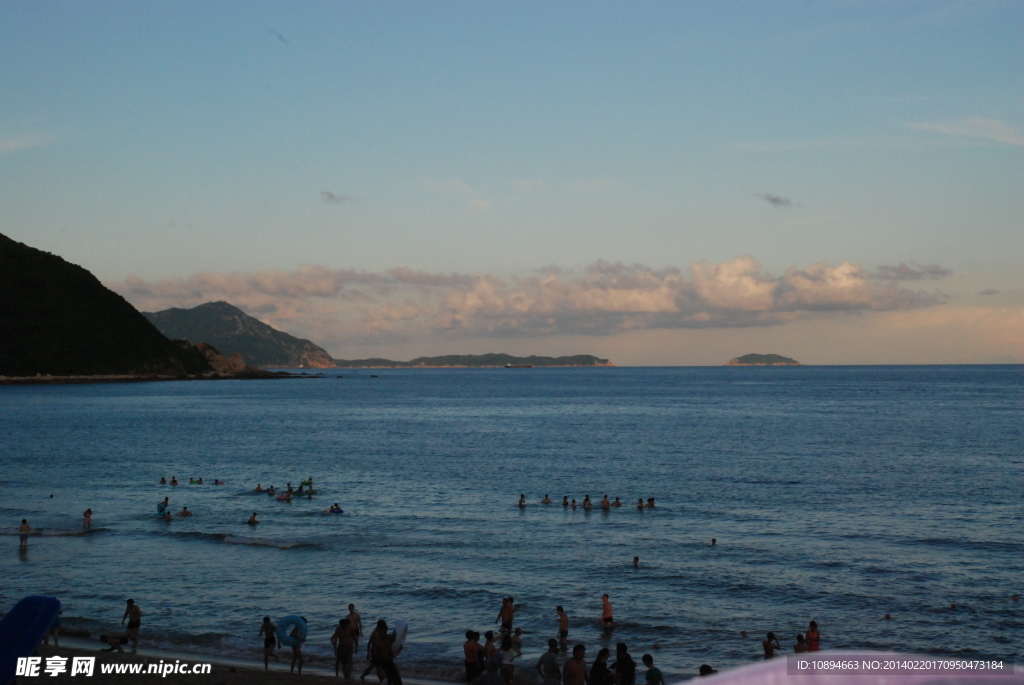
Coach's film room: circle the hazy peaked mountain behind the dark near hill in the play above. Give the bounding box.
[143,302,334,369]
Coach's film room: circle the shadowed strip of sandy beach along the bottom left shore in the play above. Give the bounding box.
[35,637,445,685]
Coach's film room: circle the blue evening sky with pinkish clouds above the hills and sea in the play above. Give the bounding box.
[0,0,1024,366]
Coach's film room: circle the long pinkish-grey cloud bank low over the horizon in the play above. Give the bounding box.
[106,256,949,348]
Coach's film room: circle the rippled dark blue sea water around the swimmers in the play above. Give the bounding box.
[0,367,1024,682]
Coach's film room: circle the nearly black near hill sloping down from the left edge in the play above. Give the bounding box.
[0,234,210,376]
